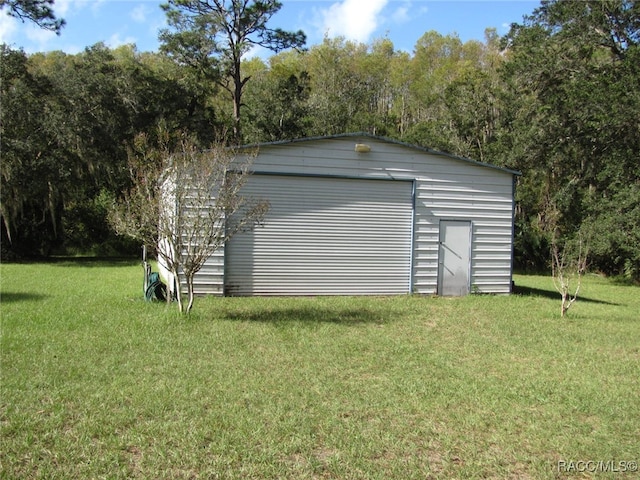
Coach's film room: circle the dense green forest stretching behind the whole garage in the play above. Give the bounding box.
[0,0,640,280]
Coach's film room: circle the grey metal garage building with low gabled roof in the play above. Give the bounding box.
[162,133,518,295]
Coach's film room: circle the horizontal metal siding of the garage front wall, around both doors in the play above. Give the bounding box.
[188,135,515,294]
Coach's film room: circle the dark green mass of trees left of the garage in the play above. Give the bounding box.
[0,44,215,256]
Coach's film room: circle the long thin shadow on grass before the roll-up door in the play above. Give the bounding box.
[225,307,388,325]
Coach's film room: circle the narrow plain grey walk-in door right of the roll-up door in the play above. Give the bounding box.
[438,220,471,296]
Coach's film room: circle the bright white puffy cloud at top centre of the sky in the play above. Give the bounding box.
[321,0,389,43]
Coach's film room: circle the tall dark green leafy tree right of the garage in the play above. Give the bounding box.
[504,0,640,282]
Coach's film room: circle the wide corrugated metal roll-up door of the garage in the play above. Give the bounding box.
[225,175,413,295]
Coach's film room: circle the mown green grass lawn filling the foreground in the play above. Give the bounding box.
[0,261,640,479]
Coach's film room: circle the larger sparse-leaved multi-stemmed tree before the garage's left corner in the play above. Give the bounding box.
[111,131,269,313]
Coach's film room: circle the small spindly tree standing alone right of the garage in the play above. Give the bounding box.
[551,235,588,317]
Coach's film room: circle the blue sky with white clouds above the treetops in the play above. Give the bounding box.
[0,0,540,54]
